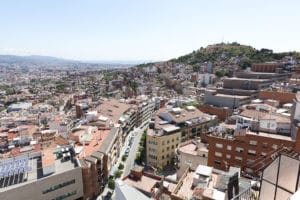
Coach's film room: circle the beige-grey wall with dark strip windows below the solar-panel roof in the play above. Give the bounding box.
[0,167,83,200]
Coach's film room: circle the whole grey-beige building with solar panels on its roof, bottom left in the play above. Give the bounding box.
[0,146,83,200]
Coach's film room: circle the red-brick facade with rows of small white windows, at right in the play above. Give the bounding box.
[201,129,296,174]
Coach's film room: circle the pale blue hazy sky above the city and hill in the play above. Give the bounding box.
[0,0,300,61]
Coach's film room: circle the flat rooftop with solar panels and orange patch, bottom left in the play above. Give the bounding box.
[0,147,77,192]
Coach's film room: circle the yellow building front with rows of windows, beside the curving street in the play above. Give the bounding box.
[146,125,181,168]
